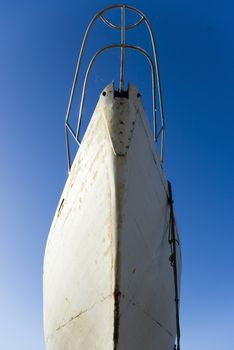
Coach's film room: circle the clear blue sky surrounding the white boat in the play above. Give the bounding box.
[0,0,234,350]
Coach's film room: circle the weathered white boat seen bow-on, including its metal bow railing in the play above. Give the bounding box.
[43,5,181,350]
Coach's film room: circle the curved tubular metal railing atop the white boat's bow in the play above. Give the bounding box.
[65,4,165,170]
